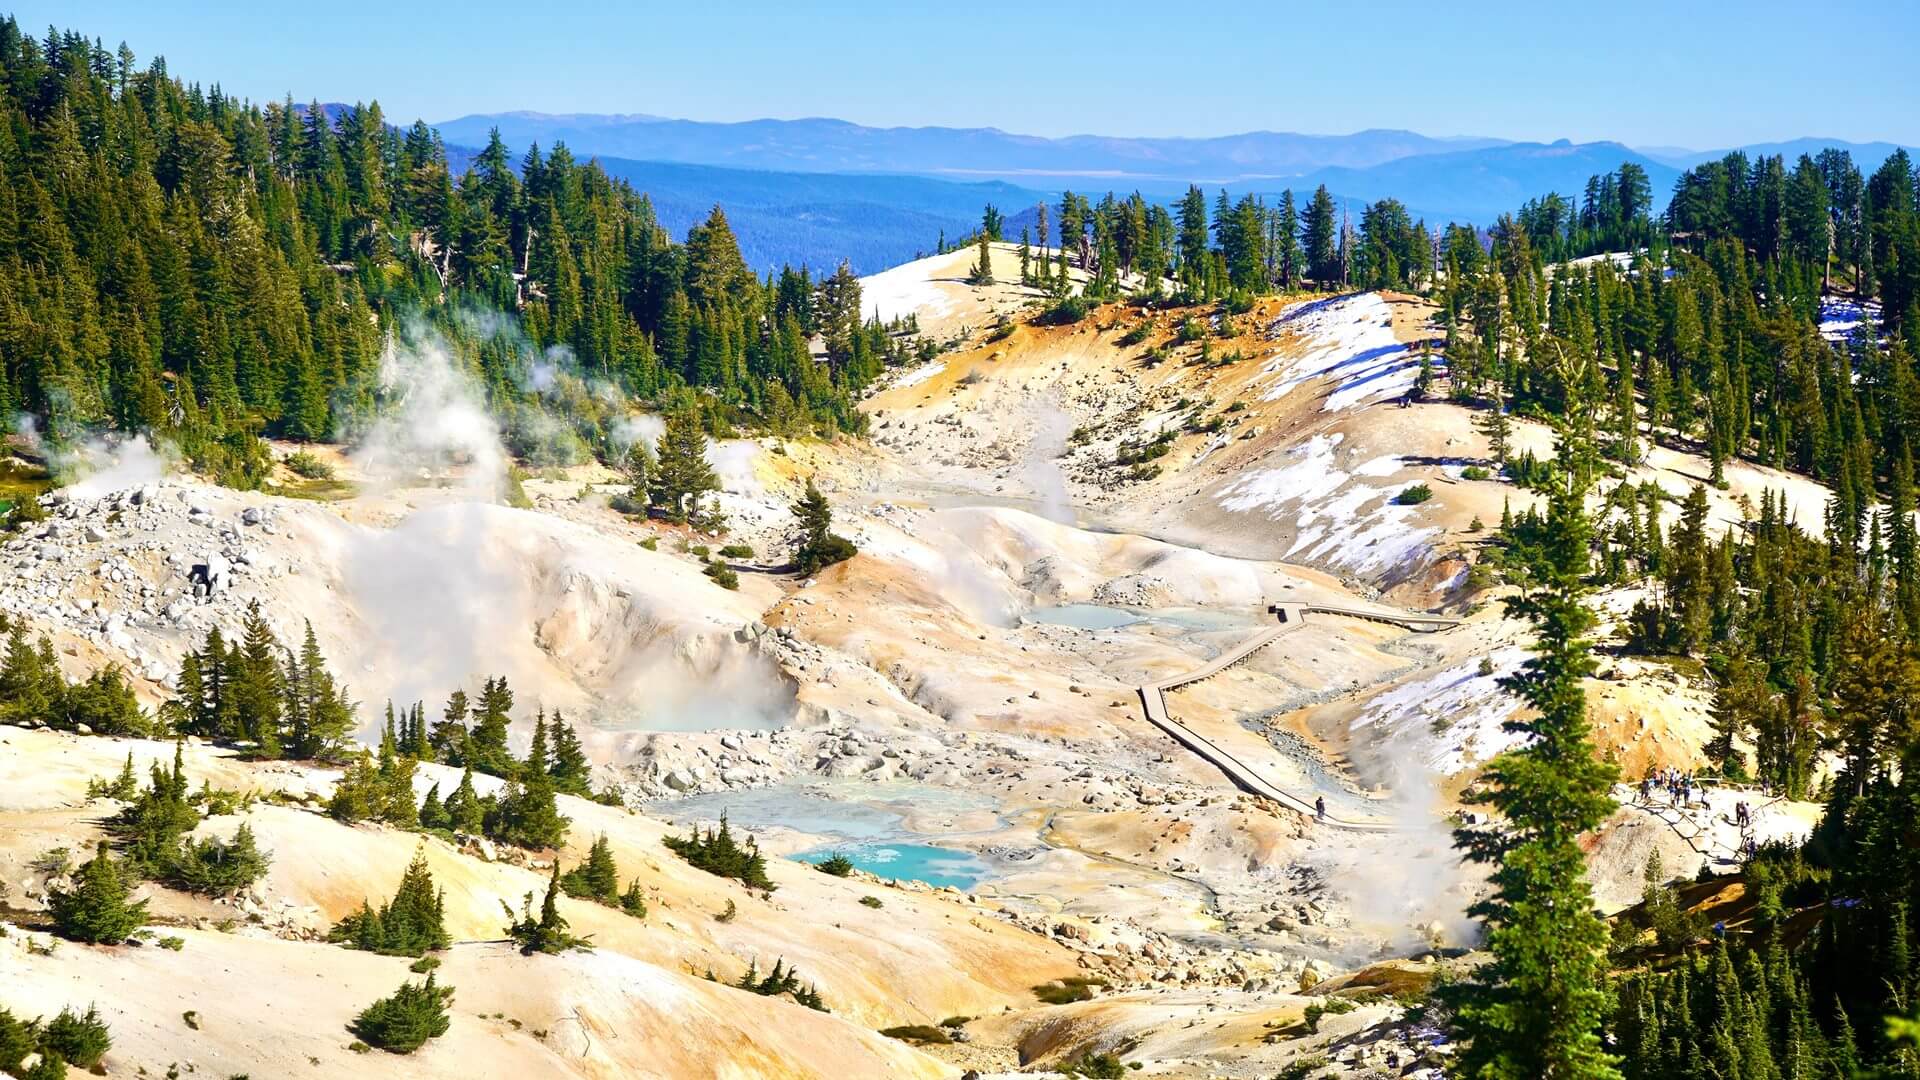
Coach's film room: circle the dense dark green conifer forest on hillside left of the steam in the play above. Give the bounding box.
[0,19,921,484]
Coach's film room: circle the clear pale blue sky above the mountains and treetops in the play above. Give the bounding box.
[15,0,1920,150]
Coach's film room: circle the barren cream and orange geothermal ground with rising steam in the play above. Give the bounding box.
[0,250,1818,1076]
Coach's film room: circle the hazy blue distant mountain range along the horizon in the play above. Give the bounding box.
[436,111,1920,273]
